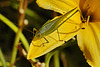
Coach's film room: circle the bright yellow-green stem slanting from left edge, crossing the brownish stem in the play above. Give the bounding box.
[0,14,36,66]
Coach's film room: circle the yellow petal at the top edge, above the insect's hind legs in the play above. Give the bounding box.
[36,0,77,14]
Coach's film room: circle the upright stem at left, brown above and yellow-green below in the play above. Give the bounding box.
[11,0,28,66]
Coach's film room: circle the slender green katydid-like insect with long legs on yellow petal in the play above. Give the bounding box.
[33,7,79,47]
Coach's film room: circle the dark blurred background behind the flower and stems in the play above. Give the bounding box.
[0,0,90,67]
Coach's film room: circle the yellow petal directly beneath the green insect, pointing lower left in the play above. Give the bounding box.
[27,13,81,59]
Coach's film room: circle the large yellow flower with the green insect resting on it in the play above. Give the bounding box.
[28,0,100,67]
